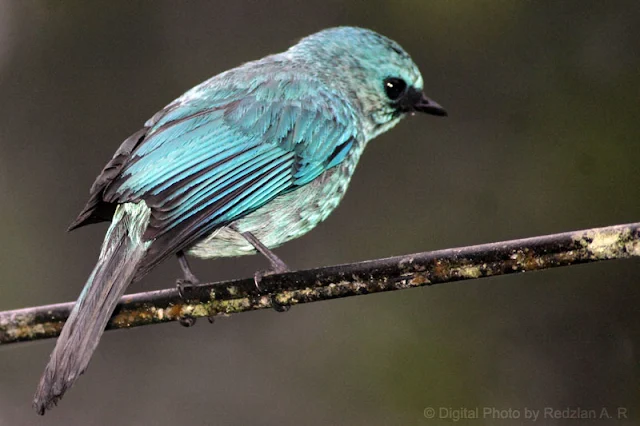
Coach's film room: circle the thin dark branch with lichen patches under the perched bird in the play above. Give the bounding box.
[0,223,640,345]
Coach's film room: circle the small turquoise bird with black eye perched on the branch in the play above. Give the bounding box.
[33,26,447,415]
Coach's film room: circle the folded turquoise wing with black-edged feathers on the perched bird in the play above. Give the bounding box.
[89,71,360,268]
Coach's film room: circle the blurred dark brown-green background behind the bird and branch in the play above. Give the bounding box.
[0,0,640,426]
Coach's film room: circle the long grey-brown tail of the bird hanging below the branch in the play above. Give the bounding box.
[33,202,150,415]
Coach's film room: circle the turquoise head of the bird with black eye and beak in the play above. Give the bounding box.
[291,27,447,138]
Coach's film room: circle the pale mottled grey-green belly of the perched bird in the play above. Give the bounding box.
[187,164,355,259]
